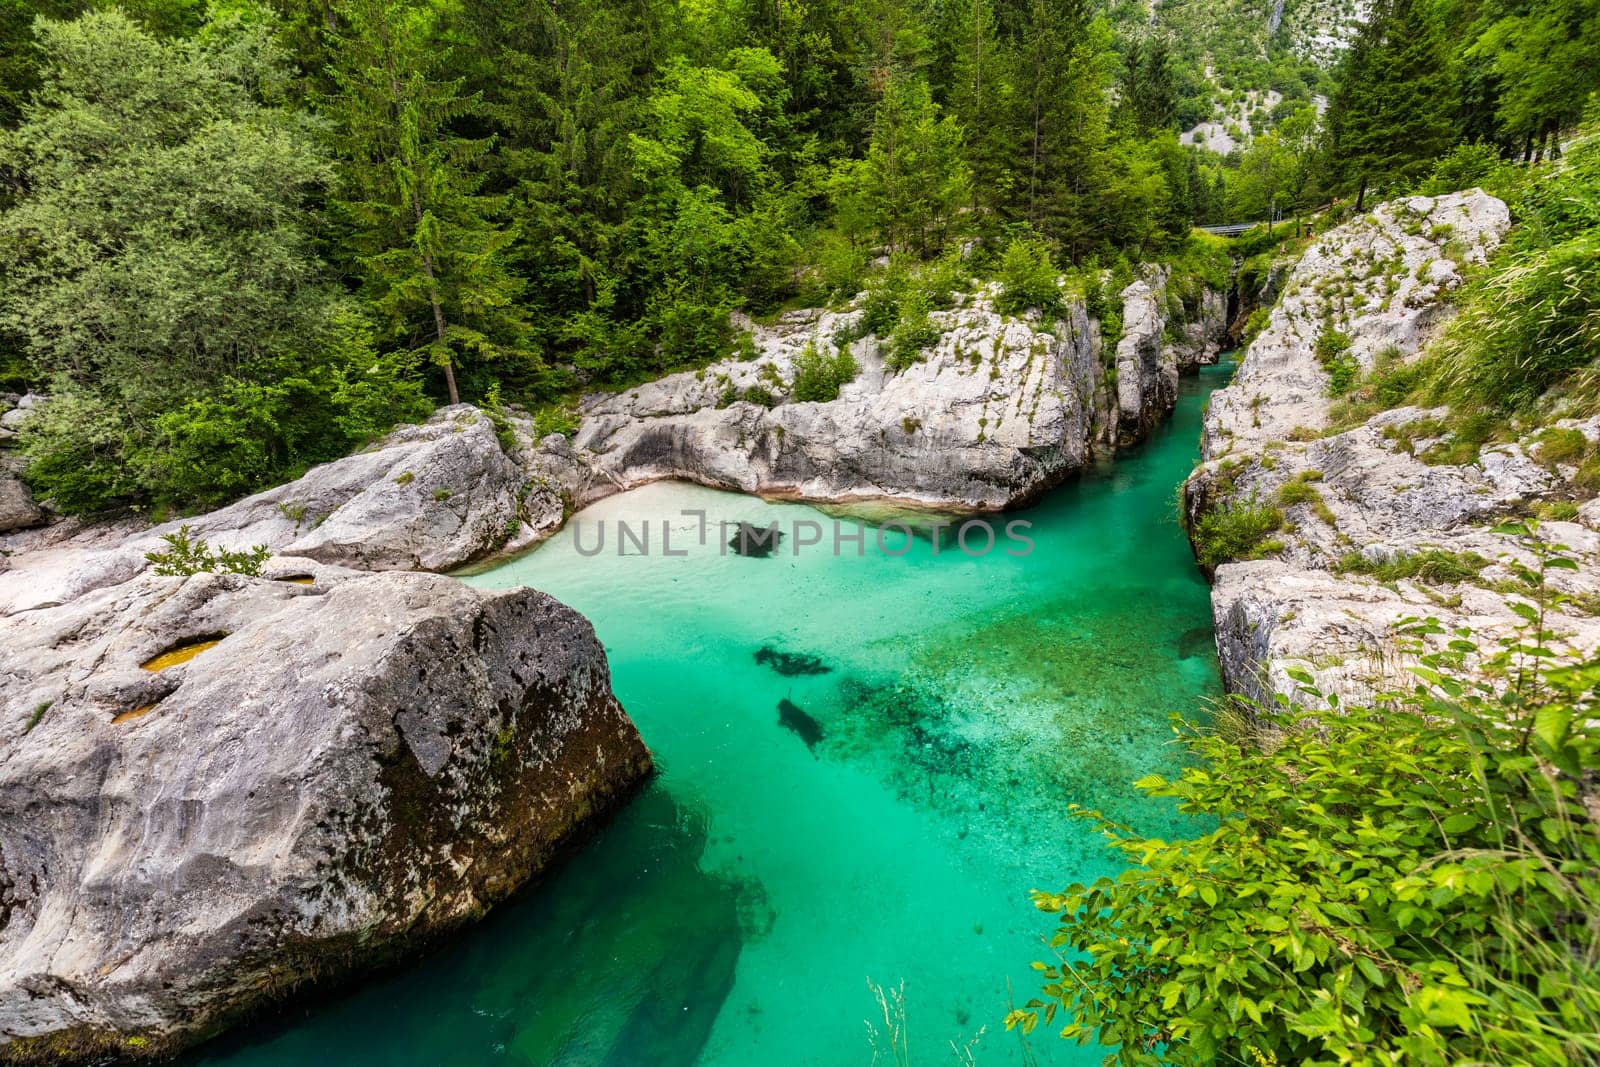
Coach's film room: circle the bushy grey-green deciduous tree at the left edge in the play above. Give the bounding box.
[0,13,426,512]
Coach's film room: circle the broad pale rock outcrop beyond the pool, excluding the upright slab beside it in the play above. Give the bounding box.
[574,295,1098,509]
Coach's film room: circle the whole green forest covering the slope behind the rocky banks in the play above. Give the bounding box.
[0,0,1600,512]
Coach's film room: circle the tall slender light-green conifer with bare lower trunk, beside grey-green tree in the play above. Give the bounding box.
[328,0,538,403]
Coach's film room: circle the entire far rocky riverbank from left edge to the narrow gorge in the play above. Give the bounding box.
[0,267,1229,598]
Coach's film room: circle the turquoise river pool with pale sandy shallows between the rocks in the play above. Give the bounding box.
[194,361,1226,1067]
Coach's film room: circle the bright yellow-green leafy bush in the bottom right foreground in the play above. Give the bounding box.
[1006,537,1600,1067]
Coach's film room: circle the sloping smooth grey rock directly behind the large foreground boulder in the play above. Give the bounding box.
[0,405,525,616]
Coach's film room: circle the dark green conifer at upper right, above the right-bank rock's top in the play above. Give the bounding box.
[1328,0,1456,210]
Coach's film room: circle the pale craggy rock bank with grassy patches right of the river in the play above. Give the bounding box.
[1184,190,1600,701]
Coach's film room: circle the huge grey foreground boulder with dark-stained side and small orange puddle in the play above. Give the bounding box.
[0,560,650,1062]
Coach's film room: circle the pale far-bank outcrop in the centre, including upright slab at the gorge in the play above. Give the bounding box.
[576,279,1226,522]
